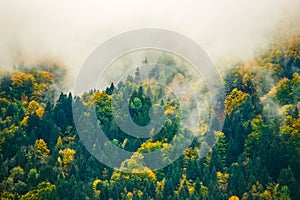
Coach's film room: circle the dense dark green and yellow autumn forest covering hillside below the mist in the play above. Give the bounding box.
[0,36,300,200]
